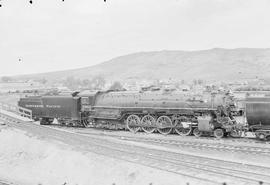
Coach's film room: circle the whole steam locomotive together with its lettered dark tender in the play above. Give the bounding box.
[18,90,237,138]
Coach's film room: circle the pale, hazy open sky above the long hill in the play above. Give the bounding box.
[0,0,270,76]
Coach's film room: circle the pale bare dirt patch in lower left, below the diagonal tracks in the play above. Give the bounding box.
[0,126,206,185]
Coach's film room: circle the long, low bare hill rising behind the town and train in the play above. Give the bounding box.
[12,48,270,81]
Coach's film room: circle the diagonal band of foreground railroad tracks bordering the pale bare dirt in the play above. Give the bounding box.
[1,113,270,184]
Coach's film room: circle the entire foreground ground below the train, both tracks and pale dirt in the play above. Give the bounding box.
[0,117,270,185]
